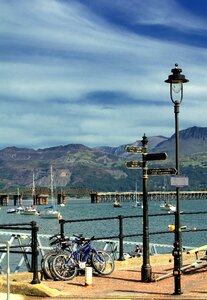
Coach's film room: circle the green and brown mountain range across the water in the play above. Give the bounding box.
[0,127,207,191]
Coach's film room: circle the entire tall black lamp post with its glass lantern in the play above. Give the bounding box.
[165,64,189,295]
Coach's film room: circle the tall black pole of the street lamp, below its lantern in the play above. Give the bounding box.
[173,101,182,295]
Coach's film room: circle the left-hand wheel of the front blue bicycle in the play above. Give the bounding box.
[52,254,78,280]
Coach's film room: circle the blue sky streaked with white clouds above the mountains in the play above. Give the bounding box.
[0,0,207,149]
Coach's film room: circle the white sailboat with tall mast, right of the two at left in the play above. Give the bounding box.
[40,165,60,219]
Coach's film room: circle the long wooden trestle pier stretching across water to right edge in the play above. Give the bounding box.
[91,191,207,203]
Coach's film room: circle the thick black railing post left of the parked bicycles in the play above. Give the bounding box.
[31,221,40,284]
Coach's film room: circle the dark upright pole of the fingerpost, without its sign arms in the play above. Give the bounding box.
[141,135,152,282]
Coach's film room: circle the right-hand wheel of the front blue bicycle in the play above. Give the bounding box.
[92,250,115,275]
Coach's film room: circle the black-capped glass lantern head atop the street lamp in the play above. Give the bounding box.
[165,64,189,104]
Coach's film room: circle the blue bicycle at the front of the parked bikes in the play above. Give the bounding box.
[52,236,115,280]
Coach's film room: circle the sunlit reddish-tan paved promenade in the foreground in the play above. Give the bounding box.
[0,254,207,300]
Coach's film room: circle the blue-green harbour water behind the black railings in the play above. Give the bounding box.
[0,199,207,274]
